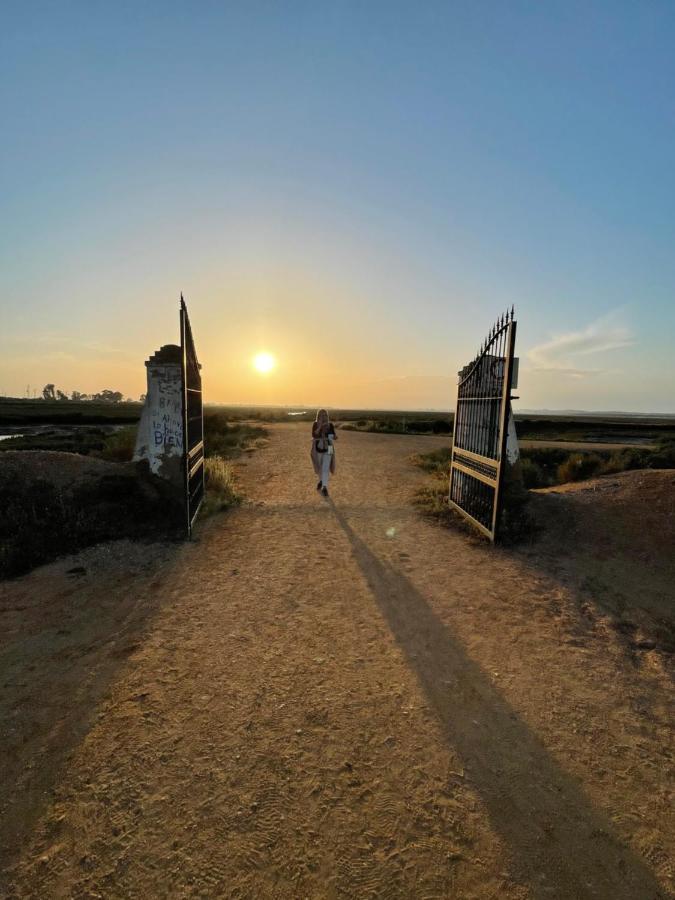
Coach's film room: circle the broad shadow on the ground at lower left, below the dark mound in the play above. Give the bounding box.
[0,545,182,896]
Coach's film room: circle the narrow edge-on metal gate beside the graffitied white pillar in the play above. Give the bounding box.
[180,294,204,537]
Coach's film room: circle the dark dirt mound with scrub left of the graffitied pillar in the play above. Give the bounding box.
[0,451,182,577]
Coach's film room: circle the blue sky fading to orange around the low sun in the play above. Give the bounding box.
[0,0,675,413]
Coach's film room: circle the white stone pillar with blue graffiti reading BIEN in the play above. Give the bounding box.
[134,344,184,492]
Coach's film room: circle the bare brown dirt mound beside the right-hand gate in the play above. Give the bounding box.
[524,470,675,652]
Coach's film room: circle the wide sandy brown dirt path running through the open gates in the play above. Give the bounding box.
[0,425,675,900]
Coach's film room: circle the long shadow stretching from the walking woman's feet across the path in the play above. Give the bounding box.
[331,503,665,900]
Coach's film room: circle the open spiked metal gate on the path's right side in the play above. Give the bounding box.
[449,307,516,541]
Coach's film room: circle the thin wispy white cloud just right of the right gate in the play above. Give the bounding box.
[527,316,635,378]
